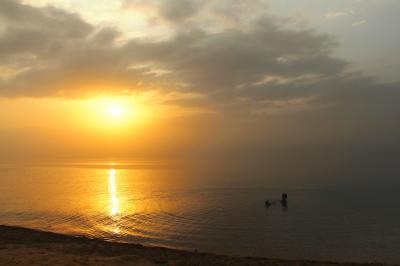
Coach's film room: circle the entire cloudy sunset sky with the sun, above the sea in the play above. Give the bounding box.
[0,0,400,183]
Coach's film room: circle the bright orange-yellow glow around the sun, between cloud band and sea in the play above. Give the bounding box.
[0,94,212,160]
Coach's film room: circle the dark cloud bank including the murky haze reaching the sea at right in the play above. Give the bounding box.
[0,0,400,187]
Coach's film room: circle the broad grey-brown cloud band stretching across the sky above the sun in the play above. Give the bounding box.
[0,0,398,121]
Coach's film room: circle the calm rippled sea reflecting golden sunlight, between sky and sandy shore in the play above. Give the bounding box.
[0,163,400,263]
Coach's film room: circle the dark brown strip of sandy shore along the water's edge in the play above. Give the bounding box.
[0,225,390,266]
